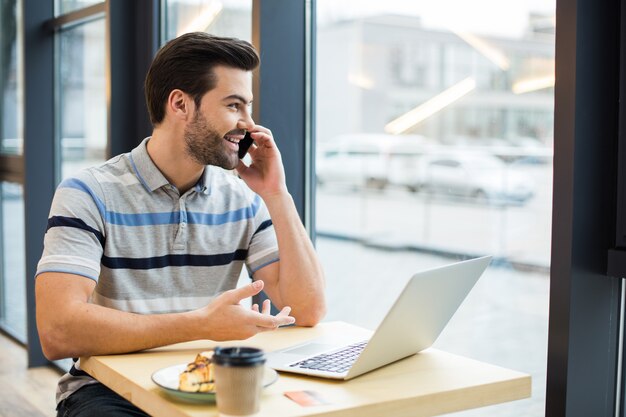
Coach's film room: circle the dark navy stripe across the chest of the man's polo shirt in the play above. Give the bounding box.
[102,249,248,269]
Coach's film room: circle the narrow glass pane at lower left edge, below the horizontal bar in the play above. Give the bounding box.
[0,182,26,343]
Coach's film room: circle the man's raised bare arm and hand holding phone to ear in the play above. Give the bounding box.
[237,126,326,326]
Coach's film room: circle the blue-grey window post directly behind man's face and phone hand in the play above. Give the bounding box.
[252,0,315,230]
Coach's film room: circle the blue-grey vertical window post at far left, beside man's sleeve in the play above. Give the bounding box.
[22,0,56,366]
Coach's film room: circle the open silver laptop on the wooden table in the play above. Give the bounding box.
[266,256,491,380]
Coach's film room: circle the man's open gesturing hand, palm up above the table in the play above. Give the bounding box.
[202,281,295,340]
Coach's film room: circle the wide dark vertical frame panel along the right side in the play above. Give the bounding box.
[546,0,621,417]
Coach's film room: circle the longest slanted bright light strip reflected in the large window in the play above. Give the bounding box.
[385,77,476,135]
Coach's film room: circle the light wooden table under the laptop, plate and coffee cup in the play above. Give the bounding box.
[81,322,531,417]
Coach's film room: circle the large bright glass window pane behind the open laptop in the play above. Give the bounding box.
[316,0,555,417]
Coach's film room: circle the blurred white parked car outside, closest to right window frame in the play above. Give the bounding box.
[406,153,534,203]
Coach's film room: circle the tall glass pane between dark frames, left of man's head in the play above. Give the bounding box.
[57,19,107,178]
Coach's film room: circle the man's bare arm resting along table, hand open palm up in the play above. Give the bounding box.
[35,272,294,360]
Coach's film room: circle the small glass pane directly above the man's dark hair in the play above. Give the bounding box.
[165,0,252,42]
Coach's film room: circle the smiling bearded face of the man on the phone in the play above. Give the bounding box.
[184,66,254,170]
